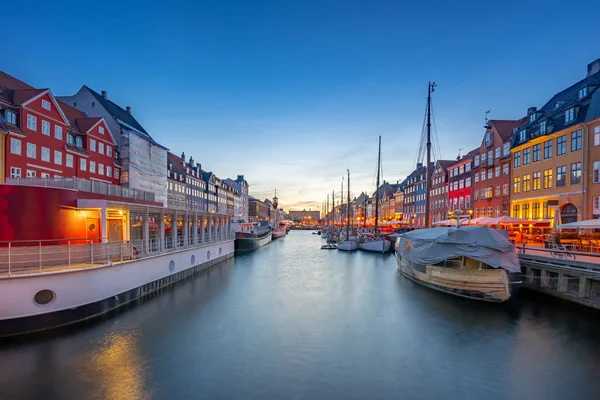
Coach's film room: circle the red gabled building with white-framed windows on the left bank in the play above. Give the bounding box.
[0,72,121,184]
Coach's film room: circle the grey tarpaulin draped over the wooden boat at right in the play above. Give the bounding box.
[396,226,521,272]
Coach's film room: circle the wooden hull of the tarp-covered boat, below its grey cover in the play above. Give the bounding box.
[396,253,512,303]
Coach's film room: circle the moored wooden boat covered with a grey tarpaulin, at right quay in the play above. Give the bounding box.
[395,226,521,302]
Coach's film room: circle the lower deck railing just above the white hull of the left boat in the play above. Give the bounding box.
[0,231,235,277]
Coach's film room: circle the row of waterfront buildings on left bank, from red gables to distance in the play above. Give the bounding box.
[0,67,255,227]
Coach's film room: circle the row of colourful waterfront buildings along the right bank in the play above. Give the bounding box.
[324,59,600,228]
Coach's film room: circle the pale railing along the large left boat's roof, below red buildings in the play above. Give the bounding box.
[6,178,155,201]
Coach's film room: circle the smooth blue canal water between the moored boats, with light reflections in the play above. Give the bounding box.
[0,231,600,400]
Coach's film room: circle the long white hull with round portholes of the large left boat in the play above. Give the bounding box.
[0,240,234,337]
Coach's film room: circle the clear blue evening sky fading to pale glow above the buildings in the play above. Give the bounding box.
[0,0,600,209]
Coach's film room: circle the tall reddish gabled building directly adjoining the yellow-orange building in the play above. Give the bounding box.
[473,120,523,218]
